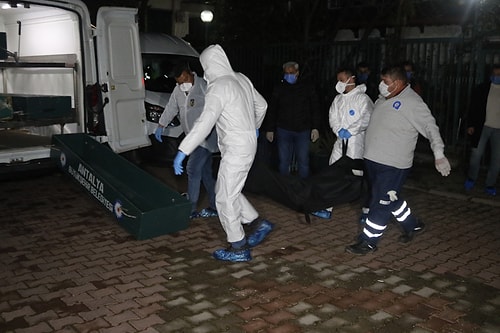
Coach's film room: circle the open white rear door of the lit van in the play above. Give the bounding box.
[96,7,151,153]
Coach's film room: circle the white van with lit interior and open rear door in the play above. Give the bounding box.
[0,0,147,174]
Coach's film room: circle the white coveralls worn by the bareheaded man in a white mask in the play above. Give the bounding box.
[328,84,373,165]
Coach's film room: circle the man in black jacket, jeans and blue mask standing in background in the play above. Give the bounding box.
[265,61,321,178]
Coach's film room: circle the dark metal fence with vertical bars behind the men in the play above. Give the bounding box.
[226,38,500,155]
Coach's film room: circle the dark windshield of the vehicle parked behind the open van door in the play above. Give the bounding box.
[142,53,203,93]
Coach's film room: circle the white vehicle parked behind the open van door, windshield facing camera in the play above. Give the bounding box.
[140,33,203,162]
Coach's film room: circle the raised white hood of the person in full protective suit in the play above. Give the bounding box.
[200,44,234,83]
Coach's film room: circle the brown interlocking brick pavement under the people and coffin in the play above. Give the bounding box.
[0,164,500,333]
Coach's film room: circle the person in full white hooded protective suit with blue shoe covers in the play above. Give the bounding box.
[174,45,274,261]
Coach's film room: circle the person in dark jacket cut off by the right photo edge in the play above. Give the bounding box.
[464,64,500,196]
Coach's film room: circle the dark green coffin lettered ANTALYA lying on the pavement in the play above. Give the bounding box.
[50,134,191,240]
